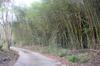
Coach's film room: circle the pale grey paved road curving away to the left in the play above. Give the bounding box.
[11,47,63,66]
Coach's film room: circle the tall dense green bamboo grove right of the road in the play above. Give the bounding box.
[12,0,100,49]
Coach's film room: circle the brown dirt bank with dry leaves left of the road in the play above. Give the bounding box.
[0,50,19,66]
